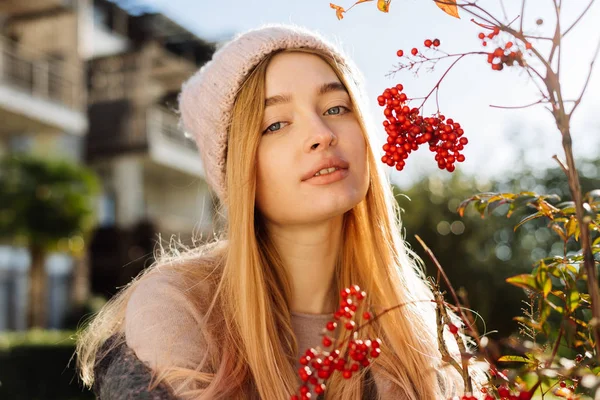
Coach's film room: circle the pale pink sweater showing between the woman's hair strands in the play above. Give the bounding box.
[125,273,438,400]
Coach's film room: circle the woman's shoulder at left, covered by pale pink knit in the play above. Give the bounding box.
[124,250,223,369]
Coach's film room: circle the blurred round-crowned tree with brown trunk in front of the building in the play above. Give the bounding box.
[0,154,99,328]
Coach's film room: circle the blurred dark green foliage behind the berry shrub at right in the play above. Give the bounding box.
[394,156,600,339]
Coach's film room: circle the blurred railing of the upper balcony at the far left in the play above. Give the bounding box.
[0,37,83,109]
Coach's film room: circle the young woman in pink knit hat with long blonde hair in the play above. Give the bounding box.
[77,25,472,400]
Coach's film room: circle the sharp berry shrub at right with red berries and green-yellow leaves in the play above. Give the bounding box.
[328,0,600,400]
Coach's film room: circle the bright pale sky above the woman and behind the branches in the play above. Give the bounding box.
[129,0,600,187]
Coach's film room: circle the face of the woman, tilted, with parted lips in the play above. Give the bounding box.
[256,52,369,224]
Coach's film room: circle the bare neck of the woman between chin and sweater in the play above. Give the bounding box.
[267,215,343,314]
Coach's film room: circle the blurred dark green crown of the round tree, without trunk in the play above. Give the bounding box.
[0,153,100,250]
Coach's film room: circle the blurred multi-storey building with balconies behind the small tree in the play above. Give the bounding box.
[0,0,219,330]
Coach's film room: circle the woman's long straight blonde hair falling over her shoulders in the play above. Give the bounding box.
[77,49,462,400]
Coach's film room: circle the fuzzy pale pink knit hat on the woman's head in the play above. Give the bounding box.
[179,24,360,203]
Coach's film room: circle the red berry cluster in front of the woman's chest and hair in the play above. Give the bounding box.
[291,285,381,400]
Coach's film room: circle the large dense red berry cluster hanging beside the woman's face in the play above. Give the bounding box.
[377,84,469,172]
